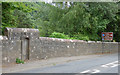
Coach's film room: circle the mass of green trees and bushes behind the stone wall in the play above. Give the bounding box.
[2,2,120,41]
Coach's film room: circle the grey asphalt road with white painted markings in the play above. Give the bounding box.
[16,54,119,73]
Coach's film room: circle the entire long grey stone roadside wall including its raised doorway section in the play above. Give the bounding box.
[0,28,118,64]
